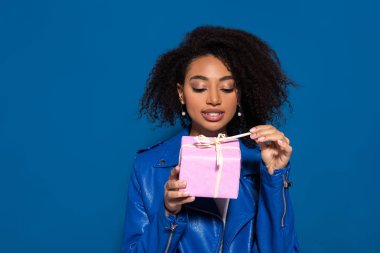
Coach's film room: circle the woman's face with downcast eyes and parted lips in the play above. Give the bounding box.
[177,55,238,137]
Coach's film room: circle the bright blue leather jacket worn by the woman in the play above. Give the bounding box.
[123,130,298,253]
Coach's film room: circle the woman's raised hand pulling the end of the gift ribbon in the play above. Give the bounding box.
[249,125,293,175]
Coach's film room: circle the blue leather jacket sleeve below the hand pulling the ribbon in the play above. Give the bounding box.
[253,161,299,253]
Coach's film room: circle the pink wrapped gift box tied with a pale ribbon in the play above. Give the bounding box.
[179,136,241,199]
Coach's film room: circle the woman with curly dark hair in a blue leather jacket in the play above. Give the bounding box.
[123,26,298,252]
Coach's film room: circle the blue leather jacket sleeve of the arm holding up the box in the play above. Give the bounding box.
[122,163,187,253]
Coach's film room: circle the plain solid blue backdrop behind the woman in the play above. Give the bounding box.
[0,0,380,253]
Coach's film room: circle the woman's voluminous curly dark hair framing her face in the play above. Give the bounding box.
[140,26,296,146]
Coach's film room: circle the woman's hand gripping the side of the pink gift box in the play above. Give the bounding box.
[164,166,195,216]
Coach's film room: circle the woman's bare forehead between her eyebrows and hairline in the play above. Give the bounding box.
[186,55,231,77]
